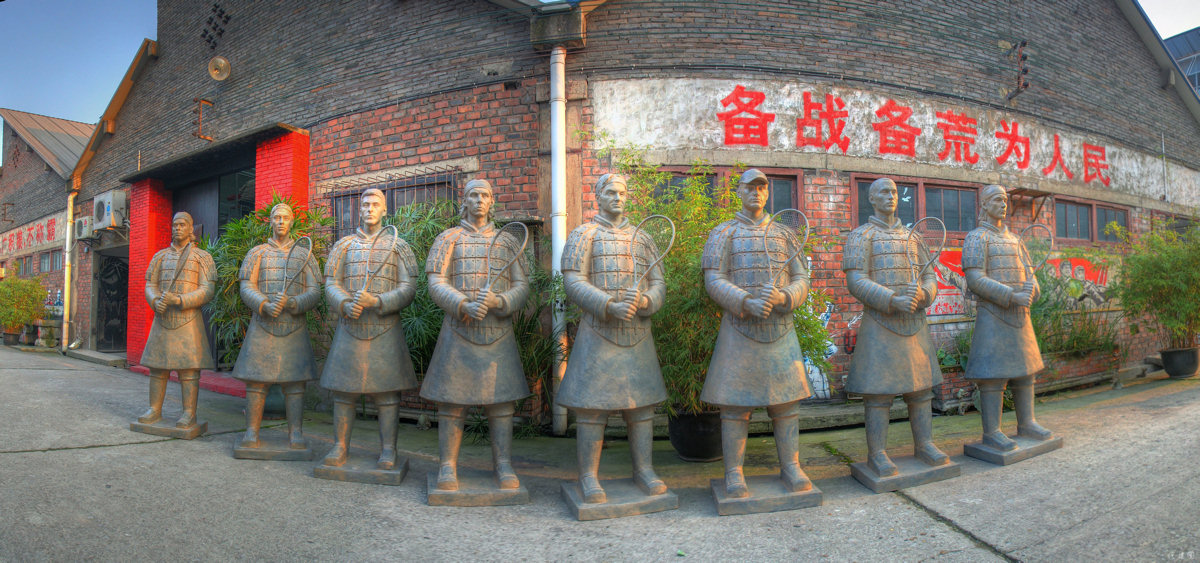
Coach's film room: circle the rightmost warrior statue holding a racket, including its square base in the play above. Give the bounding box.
[962,185,1062,465]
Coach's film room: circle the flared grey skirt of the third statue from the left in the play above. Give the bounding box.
[320,319,416,394]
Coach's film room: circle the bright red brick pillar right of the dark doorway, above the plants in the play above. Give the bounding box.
[254,132,308,208]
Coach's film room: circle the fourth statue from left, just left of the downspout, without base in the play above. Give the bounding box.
[421,180,529,491]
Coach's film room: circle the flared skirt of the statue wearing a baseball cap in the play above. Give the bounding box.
[700,315,812,407]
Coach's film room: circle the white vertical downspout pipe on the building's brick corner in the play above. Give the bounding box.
[550,44,566,436]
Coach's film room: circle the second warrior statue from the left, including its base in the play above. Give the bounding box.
[233,203,320,460]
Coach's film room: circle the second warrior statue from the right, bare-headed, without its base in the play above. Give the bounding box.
[842,178,950,478]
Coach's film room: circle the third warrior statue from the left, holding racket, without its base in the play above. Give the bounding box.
[320,188,418,471]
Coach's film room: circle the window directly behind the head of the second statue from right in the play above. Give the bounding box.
[852,174,979,233]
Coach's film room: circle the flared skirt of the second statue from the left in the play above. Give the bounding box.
[233,317,317,383]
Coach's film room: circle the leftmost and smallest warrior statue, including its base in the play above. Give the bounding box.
[130,211,216,439]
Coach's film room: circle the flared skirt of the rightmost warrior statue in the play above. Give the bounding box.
[965,307,1045,379]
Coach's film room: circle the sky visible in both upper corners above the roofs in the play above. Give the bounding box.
[0,0,1200,164]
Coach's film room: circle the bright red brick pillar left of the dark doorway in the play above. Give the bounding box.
[125,179,172,364]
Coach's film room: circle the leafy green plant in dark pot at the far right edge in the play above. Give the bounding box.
[1109,222,1200,378]
